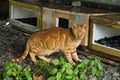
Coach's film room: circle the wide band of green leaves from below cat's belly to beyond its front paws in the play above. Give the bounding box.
[37,56,102,80]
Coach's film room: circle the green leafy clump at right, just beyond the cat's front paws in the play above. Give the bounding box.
[77,56,102,80]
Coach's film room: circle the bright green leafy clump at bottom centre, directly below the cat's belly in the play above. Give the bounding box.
[47,57,79,80]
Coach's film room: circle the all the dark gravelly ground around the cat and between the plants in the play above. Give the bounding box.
[0,20,120,80]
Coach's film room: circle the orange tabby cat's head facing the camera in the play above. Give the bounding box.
[72,24,86,40]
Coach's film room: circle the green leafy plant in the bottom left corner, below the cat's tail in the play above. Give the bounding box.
[3,61,32,80]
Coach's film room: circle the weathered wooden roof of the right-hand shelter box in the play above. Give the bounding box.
[90,13,120,29]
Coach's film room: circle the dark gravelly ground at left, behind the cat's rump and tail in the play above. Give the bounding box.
[0,23,32,69]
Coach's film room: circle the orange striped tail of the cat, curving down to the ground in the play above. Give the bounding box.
[11,44,29,62]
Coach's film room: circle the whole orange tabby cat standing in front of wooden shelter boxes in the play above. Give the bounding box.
[12,24,86,65]
